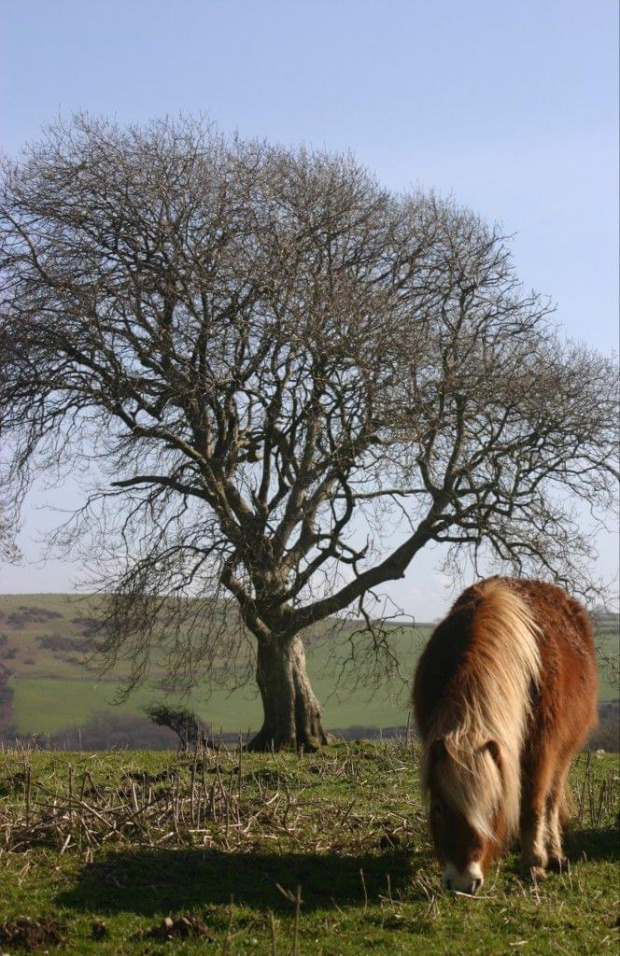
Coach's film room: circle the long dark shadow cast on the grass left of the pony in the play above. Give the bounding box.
[56,849,412,916]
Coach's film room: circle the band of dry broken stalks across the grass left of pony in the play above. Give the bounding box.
[0,745,419,859]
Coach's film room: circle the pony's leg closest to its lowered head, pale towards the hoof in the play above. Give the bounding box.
[521,754,553,880]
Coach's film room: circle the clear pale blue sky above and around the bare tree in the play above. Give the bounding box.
[0,0,618,620]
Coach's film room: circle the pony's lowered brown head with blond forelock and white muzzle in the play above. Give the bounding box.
[425,738,506,894]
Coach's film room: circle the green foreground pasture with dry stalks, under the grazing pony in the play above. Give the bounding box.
[0,741,620,956]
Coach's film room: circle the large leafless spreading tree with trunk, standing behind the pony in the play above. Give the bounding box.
[0,117,615,748]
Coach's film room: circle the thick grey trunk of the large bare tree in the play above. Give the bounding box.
[248,635,328,750]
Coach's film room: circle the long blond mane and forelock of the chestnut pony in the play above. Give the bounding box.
[422,579,541,838]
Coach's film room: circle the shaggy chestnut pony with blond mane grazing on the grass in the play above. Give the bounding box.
[413,578,596,894]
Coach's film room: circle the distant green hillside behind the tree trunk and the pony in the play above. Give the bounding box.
[0,594,618,746]
